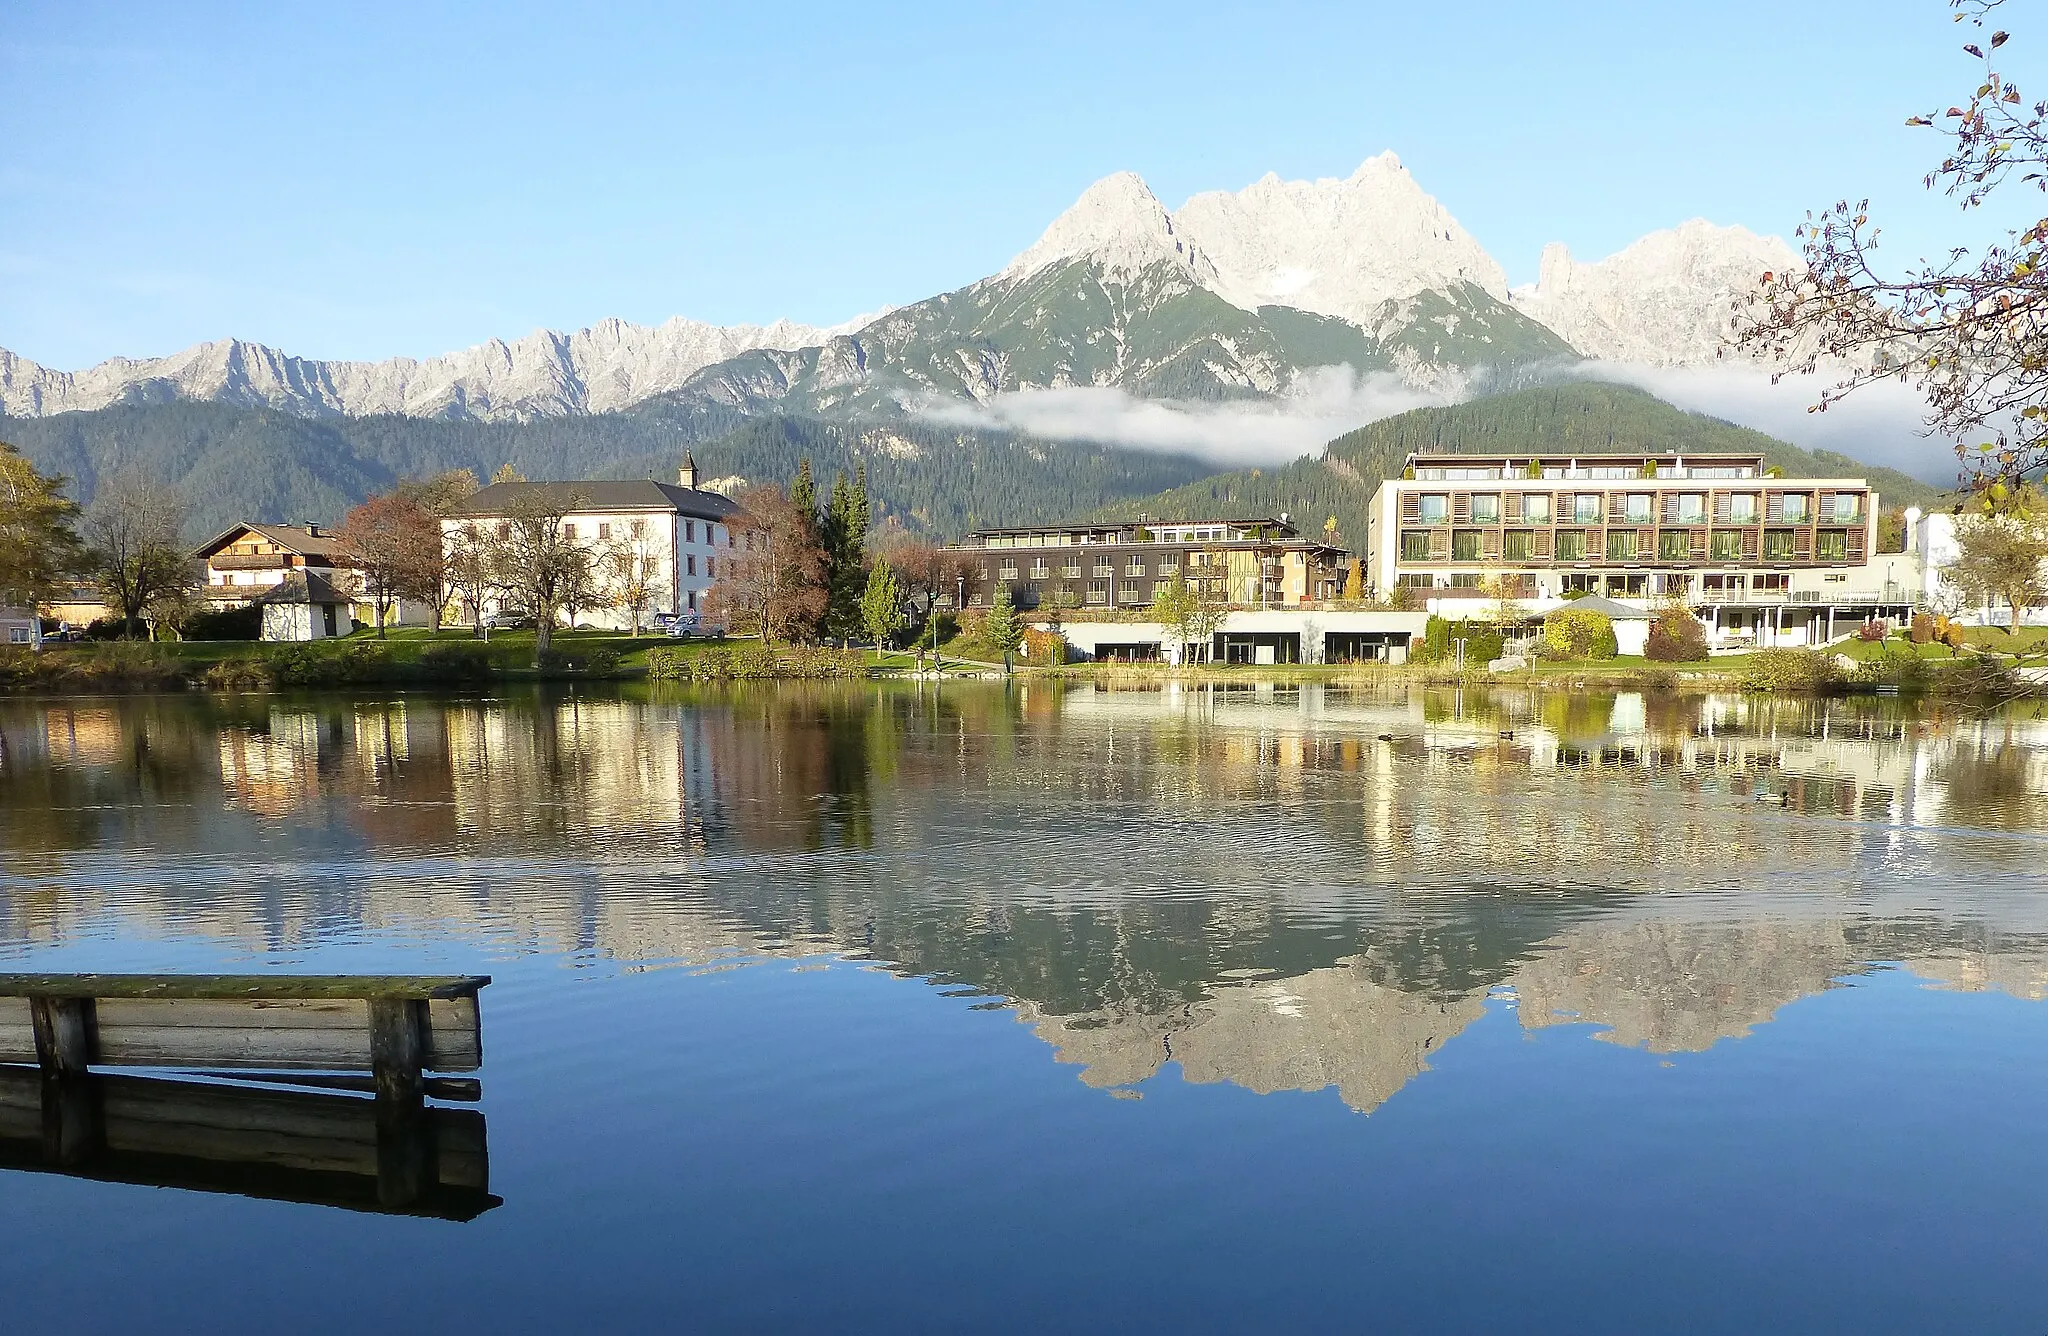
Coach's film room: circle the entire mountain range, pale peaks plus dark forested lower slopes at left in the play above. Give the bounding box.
[0,154,1875,533]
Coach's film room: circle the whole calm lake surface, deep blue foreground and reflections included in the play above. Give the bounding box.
[0,686,2048,1336]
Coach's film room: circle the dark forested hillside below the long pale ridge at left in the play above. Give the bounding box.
[0,402,1208,537]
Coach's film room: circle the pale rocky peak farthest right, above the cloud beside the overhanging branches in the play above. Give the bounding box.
[1511,219,1800,367]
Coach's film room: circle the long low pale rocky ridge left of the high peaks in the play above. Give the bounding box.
[0,316,864,420]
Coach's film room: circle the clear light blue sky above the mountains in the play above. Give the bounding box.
[0,0,2015,369]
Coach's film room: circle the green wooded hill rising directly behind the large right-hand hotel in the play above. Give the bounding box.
[1100,381,1942,547]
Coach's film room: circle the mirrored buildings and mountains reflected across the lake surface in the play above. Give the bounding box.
[0,684,2048,1111]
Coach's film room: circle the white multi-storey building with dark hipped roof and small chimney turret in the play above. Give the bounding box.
[442,457,739,629]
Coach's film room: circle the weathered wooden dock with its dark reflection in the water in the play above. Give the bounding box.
[0,975,500,1219]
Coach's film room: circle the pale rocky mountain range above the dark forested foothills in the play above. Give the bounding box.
[0,154,1794,422]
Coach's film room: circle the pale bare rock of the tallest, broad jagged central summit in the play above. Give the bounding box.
[1174,152,1507,326]
